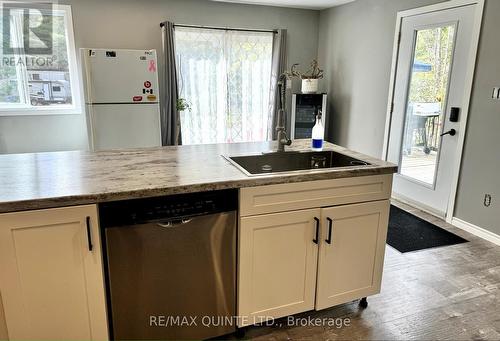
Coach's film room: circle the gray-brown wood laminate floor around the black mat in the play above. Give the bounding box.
[233,202,500,340]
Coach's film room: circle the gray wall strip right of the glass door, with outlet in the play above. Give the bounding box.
[455,0,500,235]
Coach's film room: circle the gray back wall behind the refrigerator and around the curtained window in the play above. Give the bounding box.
[0,0,319,153]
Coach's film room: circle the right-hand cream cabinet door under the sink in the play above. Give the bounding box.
[316,200,390,310]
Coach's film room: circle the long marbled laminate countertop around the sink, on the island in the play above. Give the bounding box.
[0,140,397,213]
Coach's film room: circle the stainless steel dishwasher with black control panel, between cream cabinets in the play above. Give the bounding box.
[99,190,238,340]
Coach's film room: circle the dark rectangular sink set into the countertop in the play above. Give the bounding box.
[224,151,370,176]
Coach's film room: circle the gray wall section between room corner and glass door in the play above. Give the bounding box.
[318,0,439,157]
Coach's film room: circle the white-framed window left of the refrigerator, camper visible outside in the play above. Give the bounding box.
[0,1,80,115]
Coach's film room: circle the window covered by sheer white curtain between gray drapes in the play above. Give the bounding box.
[175,27,273,144]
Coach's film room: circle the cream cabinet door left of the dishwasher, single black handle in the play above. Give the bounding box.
[0,205,108,340]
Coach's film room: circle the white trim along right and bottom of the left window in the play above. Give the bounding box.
[0,4,84,116]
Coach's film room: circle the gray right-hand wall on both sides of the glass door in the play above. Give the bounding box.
[318,0,500,234]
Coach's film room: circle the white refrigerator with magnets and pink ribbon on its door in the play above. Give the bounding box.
[80,49,161,151]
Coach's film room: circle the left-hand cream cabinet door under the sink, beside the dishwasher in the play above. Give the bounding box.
[238,209,320,326]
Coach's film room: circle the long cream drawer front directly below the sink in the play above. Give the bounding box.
[240,174,392,217]
